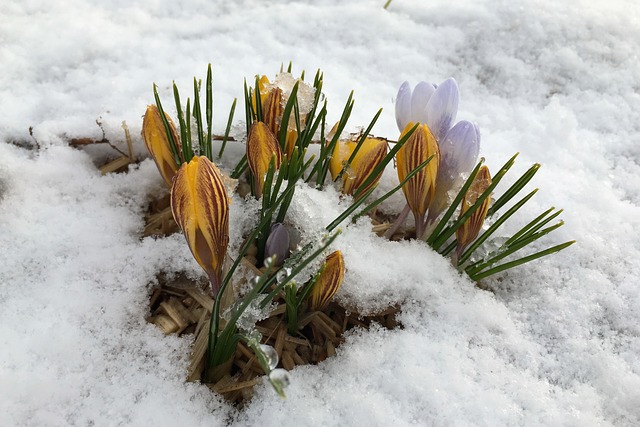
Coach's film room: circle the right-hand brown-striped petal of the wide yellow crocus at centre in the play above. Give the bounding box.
[342,138,387,195]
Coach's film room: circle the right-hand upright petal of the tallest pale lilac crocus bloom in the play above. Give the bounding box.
[425,78,460,142]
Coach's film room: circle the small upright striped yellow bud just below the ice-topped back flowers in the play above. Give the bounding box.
[247,121,282,198]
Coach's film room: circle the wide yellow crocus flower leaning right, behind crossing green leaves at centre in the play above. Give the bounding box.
[329,138,387,195]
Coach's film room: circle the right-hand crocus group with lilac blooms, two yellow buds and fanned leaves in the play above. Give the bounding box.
[387,78,574,280]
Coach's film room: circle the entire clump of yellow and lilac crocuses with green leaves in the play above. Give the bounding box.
[142,67,573,402]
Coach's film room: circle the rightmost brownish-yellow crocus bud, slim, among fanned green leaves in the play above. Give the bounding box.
[456,166,491,256]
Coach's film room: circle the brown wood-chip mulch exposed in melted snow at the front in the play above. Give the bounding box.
[147,277,400,404]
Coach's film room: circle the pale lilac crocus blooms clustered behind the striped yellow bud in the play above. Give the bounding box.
[396,78,480,229]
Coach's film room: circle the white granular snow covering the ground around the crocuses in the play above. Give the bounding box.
[0,0,640,426]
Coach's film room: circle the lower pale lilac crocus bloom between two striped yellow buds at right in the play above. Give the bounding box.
[427,120,480,223]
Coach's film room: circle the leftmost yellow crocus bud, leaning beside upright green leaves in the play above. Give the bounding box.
[142,105,182,187]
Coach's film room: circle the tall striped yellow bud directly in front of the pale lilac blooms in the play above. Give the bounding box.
[396,122,440,239]
